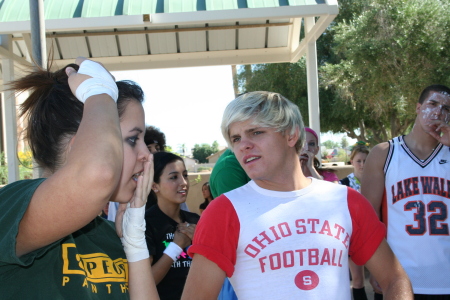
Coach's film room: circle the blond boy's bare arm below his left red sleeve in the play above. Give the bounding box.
[181,254,225,300]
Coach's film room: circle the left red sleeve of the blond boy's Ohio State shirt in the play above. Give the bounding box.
[188,195,240,277]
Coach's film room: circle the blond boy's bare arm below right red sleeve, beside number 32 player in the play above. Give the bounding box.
[366,240,414,300]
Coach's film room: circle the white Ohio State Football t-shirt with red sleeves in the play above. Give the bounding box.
[189,179,386,300]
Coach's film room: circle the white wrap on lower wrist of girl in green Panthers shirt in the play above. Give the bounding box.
[120,203,150,262]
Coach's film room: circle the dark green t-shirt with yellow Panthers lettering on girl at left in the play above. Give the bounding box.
[0,179,129,300]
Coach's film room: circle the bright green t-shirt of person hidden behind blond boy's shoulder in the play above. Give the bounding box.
[209,149,251,198]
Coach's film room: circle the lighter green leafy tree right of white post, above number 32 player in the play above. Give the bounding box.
[321,0,450,142]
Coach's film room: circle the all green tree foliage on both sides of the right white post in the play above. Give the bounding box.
[238,0,450,144]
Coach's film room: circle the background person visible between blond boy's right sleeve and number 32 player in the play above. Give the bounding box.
[339,141,369,300]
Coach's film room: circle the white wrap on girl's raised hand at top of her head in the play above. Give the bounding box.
[76,60,119,103]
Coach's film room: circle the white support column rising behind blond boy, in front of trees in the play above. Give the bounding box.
[305,17,322,161]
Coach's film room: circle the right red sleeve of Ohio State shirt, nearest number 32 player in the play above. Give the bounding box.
[347,188,386,265]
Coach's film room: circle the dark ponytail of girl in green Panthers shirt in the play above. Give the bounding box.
[9,64,83,172]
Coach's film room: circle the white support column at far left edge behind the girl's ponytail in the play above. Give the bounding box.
[0,35,19,183]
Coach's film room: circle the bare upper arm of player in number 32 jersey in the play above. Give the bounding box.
[361,142,389,219]
